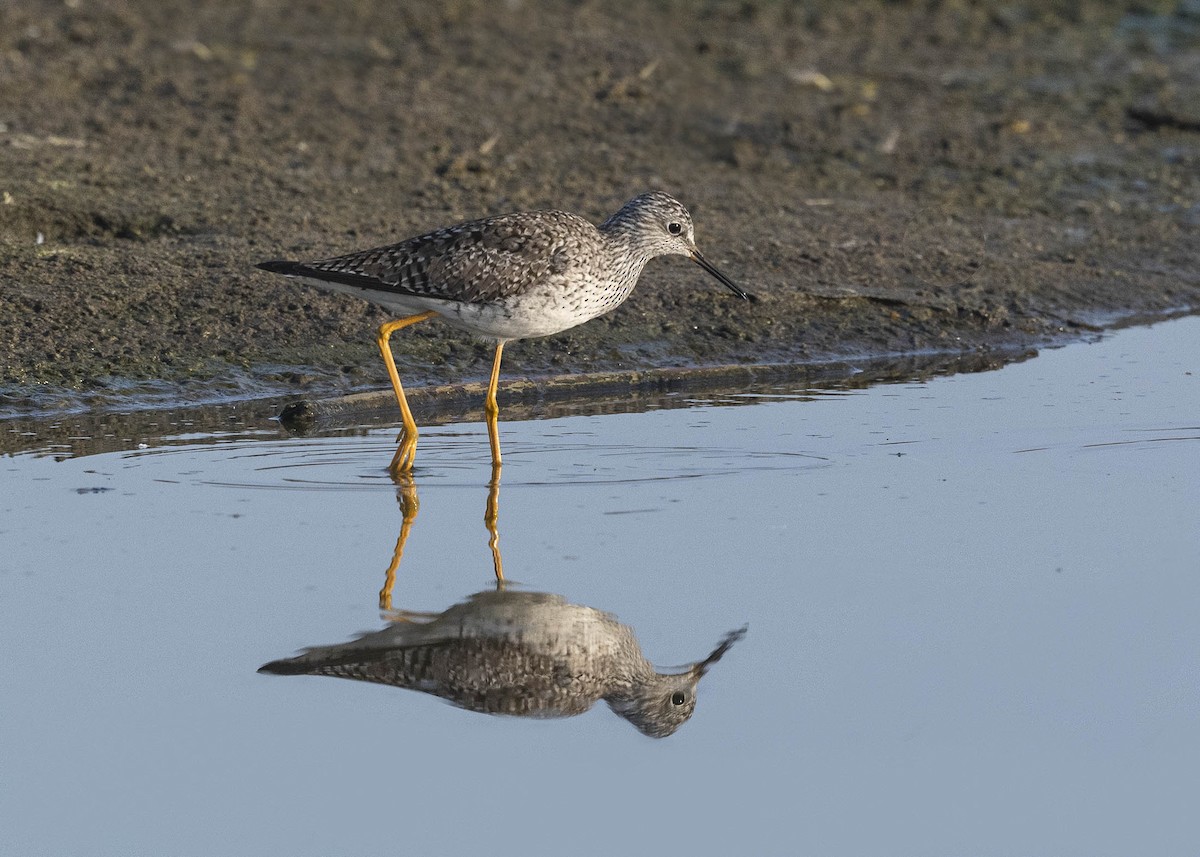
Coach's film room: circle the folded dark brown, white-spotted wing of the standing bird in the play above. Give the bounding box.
[259,211,596,304]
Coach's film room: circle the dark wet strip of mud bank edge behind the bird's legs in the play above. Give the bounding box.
[0,350,1037,459]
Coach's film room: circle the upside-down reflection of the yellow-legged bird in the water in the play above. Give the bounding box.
[266,460,746,738]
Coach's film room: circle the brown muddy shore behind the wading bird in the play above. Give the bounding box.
[0,0,1200,416]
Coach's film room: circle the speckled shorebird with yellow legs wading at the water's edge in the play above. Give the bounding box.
[258,191,750,474]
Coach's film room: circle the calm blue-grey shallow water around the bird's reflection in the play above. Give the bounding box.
[0,318,1200,855]
